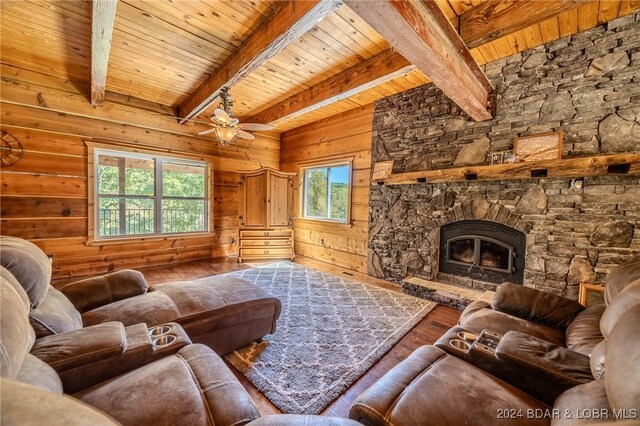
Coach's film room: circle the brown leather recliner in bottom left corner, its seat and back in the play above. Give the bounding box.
[0,267,259,426]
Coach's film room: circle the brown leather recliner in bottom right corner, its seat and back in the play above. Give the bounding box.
[349,280,640,426]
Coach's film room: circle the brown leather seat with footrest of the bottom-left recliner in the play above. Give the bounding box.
[74,344,260,426]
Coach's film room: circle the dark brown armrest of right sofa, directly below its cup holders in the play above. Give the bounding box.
[496,331,593,403]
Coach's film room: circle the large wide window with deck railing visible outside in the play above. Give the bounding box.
[94,150,209,238]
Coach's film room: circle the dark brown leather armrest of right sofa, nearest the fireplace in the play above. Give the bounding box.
[493,283,584,330]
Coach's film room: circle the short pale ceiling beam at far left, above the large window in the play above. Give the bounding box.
[91,0,118,105]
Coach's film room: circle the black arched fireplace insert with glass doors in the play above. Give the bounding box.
[439,220,526,284]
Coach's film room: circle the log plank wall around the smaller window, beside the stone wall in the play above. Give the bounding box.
[280,105,373,273]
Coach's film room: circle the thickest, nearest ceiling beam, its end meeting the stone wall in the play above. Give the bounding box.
[345,0,493,121]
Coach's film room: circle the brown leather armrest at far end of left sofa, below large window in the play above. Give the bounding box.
[58,269,149,313]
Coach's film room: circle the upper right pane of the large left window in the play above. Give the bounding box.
[162,162,205,198]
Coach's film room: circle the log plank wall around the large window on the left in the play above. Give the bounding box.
[0,64,280,280]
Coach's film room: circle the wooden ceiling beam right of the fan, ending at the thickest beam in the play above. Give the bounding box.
[245,50,415,123]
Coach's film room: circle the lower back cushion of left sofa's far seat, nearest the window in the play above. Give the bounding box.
[29,286,82,338]
